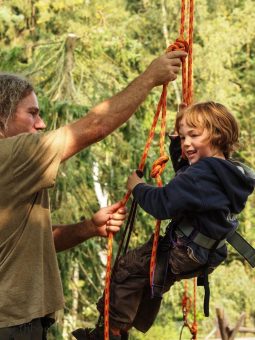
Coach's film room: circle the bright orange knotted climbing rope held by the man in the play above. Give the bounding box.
[104,0,197,340]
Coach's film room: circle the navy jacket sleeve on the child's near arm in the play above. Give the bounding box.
[133,173,204,220]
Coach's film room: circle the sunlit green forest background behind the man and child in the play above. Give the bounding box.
[0,0,255,340]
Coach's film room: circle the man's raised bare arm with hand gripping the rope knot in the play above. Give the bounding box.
[62,51,187,161]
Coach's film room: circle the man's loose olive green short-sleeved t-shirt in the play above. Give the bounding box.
[0,129,65,328]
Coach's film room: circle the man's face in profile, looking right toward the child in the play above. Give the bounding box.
[6,92,46,137]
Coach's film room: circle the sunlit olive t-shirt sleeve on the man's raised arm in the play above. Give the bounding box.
[12,128,65,195]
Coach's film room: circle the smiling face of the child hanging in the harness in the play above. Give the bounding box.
[179,116,225,164]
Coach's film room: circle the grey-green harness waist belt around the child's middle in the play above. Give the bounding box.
[177,223,226,249]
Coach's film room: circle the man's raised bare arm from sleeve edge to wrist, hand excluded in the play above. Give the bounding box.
[62,74,153,161]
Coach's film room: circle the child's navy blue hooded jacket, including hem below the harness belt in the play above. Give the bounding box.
[133,157,254,266]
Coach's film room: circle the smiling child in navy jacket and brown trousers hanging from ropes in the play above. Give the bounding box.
[74,102,254,340]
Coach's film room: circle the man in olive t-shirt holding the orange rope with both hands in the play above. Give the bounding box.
[0,51,186,340]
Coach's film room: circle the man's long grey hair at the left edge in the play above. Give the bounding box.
[0,73,34,137]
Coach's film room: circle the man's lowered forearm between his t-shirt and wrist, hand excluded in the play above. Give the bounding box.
[52,220,97,252]
